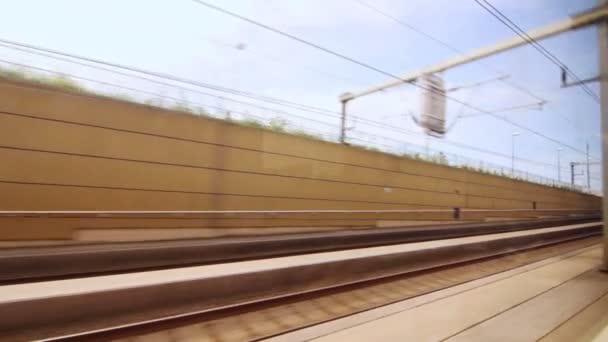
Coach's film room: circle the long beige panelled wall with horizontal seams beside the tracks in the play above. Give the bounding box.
[0,82,601,239]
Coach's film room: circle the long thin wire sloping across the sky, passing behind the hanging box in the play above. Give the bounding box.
[192,0,597,159]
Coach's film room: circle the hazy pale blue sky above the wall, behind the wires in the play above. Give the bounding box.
[0,0,600,188]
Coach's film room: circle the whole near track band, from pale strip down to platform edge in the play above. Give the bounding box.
[0,222,601,341]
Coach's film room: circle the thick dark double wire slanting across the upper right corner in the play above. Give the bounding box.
[475,0,600,103]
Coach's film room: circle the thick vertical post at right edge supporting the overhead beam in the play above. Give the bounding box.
[598,0,608,270]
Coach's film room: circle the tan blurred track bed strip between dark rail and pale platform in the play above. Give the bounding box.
[110,237,600,342]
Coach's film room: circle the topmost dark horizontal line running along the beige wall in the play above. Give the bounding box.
[0,107,583,195]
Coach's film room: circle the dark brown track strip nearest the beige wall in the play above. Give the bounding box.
[0,215,599,284]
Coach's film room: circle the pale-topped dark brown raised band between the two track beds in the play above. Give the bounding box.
[0,222,601,340]
